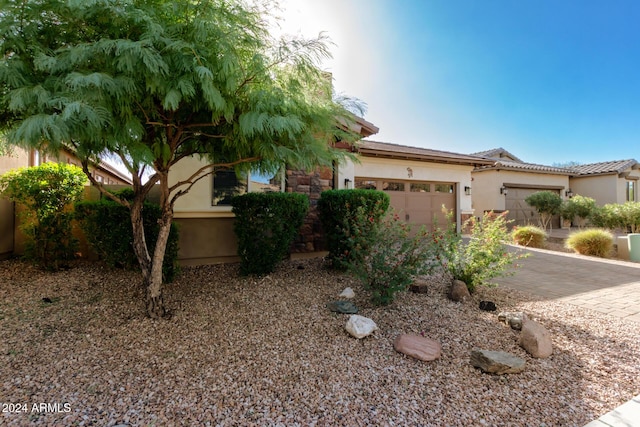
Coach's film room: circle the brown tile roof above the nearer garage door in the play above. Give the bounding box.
[357,140,493,165]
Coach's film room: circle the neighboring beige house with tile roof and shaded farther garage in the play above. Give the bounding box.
[471,148,575,228]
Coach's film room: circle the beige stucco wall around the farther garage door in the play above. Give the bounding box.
[471,170,575,216]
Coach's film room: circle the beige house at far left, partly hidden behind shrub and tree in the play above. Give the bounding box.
[0,148,131,259]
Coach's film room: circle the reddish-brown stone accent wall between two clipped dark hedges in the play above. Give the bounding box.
[286,167,333,253]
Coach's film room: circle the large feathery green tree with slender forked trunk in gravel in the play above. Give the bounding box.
[0,0,357,318]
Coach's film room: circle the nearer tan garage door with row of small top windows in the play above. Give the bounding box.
[355,178,456,230]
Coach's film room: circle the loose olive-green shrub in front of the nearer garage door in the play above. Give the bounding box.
[347,210,438,305]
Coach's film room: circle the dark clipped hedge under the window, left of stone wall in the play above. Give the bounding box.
[231,193,309,275]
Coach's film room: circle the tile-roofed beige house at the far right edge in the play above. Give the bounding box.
[568,159,640,206]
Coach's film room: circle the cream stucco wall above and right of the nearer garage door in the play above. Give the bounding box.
[351,157,473,214]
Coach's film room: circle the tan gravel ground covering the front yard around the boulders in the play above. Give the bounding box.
[0,259,640,426]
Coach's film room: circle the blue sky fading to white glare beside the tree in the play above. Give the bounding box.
[278,0,640,165]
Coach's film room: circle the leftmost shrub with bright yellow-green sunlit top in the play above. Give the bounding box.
[0,163,87,270]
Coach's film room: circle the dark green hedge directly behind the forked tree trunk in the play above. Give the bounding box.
[75,196,179,283]
